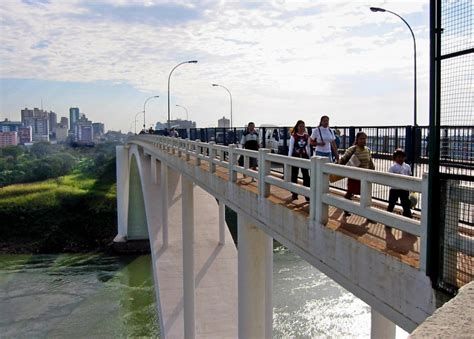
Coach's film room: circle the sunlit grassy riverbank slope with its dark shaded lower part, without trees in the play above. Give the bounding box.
[0,162,117,253]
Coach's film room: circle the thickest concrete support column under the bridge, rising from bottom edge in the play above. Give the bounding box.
[238,214,273,338]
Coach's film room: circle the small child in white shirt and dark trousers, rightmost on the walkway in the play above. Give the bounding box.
[387,148,412,218]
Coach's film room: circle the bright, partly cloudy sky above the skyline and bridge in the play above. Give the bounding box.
[0,0,429,132]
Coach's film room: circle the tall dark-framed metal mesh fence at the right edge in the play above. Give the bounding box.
[436,0,474,294]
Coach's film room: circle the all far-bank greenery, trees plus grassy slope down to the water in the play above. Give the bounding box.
[0,143,117,253]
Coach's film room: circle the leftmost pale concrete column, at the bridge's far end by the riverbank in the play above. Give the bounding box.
[115,146,130,238]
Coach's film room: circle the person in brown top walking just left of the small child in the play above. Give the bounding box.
[339,132,375,216]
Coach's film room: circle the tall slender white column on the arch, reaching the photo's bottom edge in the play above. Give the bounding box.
[181,176,196,338]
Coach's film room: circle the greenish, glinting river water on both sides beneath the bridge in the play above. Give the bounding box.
[0,247,406,338]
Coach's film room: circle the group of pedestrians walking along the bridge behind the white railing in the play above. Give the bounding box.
[241,115,412,222]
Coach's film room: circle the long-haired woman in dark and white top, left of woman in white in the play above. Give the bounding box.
[288,120,310,201]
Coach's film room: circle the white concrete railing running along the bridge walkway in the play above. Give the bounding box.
[129,136,428,270]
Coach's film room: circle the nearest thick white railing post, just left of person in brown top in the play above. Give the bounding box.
[310,157,329,225]
